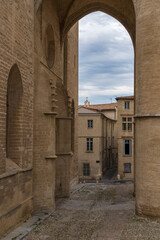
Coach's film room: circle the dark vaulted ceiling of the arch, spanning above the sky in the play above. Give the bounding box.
[35,0,135,45]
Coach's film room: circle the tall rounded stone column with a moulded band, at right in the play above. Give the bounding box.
[135,0,160,216]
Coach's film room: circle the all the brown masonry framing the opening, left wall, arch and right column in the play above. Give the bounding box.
[0,0,160,235]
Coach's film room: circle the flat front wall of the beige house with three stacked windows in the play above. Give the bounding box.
[78,113,106,180]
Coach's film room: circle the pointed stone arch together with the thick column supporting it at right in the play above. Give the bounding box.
[32,0,160,216]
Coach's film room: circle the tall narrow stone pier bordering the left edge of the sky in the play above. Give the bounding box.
[65,23,79,188]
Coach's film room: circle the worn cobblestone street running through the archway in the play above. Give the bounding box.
[25,183,160,240]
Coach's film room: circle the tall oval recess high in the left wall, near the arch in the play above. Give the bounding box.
[45,24,55,68]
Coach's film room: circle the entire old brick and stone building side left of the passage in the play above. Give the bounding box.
[0,0,78,236]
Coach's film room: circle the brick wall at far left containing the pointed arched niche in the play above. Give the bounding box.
[0,0,34,236]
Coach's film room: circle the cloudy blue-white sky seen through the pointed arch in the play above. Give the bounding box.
[79,12,134,104]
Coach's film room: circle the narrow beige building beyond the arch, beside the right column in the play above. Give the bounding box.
[116,96,134,179]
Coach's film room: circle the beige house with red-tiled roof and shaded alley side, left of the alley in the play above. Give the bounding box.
[78,104,117,181]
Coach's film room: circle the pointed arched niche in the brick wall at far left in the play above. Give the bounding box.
[6,64,23,167]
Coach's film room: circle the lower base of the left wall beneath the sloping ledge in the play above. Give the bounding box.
[0,170,33,236]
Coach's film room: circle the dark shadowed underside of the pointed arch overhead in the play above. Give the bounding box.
[61,0,135,44]
